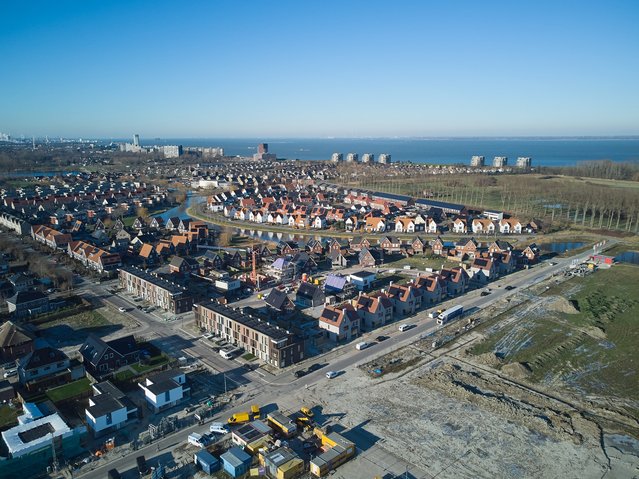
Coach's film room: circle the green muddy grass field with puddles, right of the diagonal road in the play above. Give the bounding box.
[472,265,639,412]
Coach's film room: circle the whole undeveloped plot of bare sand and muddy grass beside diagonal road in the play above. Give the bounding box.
[284,265,639,478]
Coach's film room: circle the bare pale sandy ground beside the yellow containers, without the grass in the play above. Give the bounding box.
[290,360,639,478]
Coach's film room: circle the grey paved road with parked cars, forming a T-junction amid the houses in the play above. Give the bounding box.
[76,243,613,477]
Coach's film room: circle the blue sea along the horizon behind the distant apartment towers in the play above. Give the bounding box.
[151,136,639,167]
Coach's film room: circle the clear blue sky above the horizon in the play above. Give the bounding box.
[0,0,639,138]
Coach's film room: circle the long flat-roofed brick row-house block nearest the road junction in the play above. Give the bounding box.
[194,301,304,368]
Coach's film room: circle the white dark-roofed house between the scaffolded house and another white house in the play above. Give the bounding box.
[84,381,138,436]
